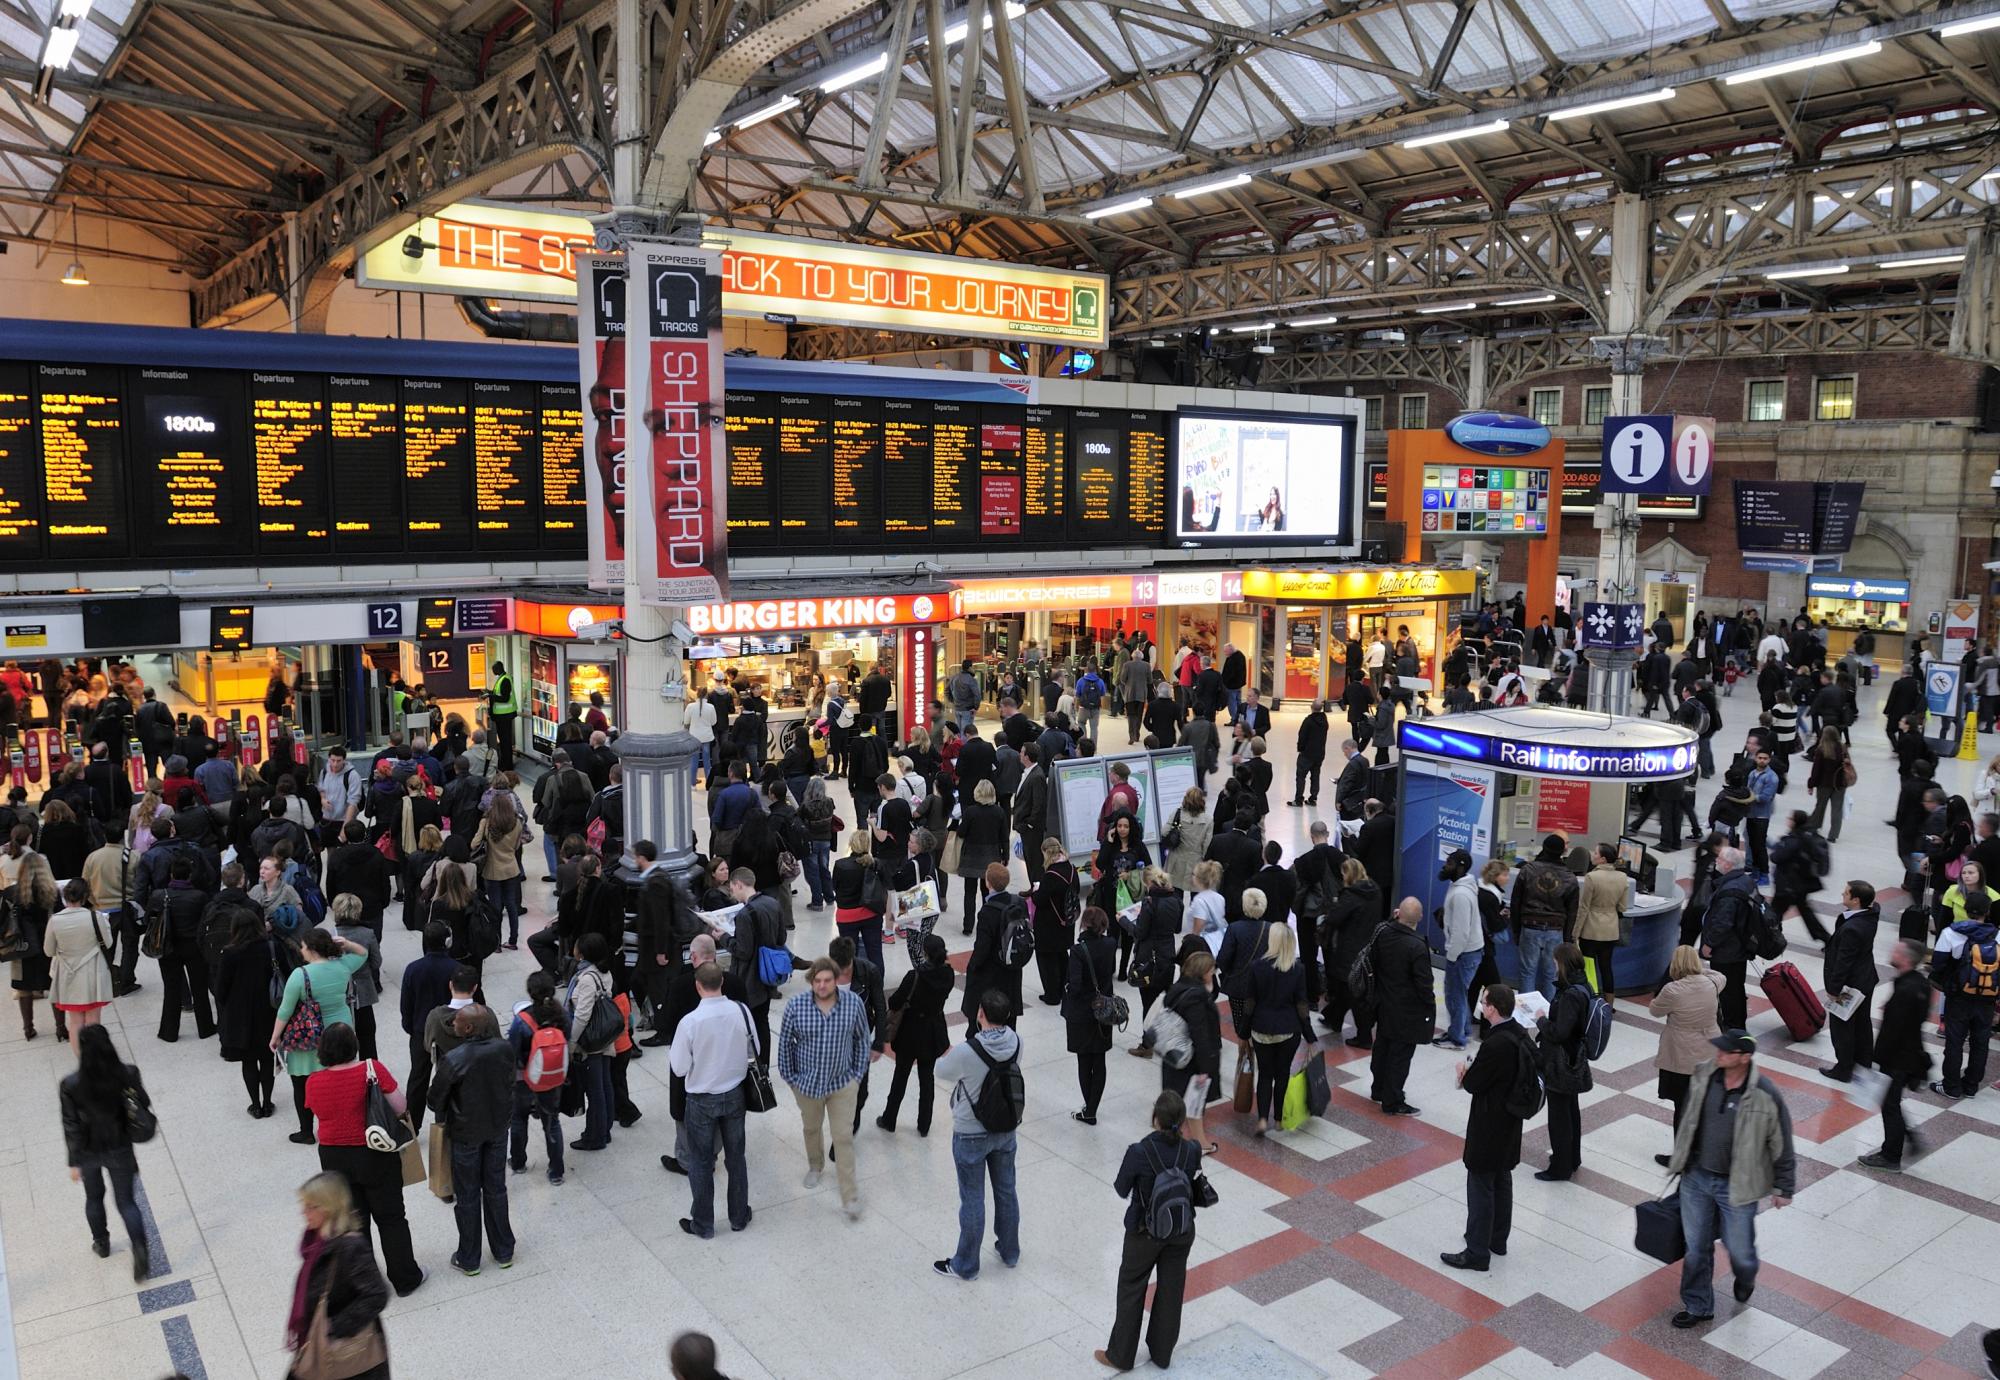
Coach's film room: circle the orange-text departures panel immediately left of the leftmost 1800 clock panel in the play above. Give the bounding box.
[36,364,132,560]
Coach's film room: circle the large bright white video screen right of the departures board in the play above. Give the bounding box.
[1174,408,1360,546]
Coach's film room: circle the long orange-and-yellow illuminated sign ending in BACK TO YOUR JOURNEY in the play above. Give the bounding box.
[356,202,1110,352]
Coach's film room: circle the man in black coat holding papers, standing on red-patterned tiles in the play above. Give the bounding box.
[1440,980,1548,1270]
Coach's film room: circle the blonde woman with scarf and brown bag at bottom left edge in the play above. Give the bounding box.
[284,1172,390,1380]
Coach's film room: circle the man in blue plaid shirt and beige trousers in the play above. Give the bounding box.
[778,958,882,1220]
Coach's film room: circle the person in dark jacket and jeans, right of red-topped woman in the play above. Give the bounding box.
[430,1006,514,1274]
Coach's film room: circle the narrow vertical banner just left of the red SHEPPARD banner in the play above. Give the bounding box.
[576,254,626,592]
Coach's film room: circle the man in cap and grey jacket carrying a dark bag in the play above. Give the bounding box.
[1666,1030,1798,1328]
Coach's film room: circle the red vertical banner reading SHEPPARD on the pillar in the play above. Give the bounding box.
[626,240,730,604]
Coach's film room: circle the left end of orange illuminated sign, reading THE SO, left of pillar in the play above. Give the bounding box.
[354,202,596,302]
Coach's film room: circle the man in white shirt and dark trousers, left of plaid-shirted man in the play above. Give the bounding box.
[666,962,750,1240]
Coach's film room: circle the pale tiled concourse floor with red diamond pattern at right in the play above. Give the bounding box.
[0,690,2000,1380]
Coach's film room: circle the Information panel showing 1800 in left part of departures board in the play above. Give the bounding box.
[128,368,250,556]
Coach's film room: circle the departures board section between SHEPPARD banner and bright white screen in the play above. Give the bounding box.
[724,390,1170,552]
